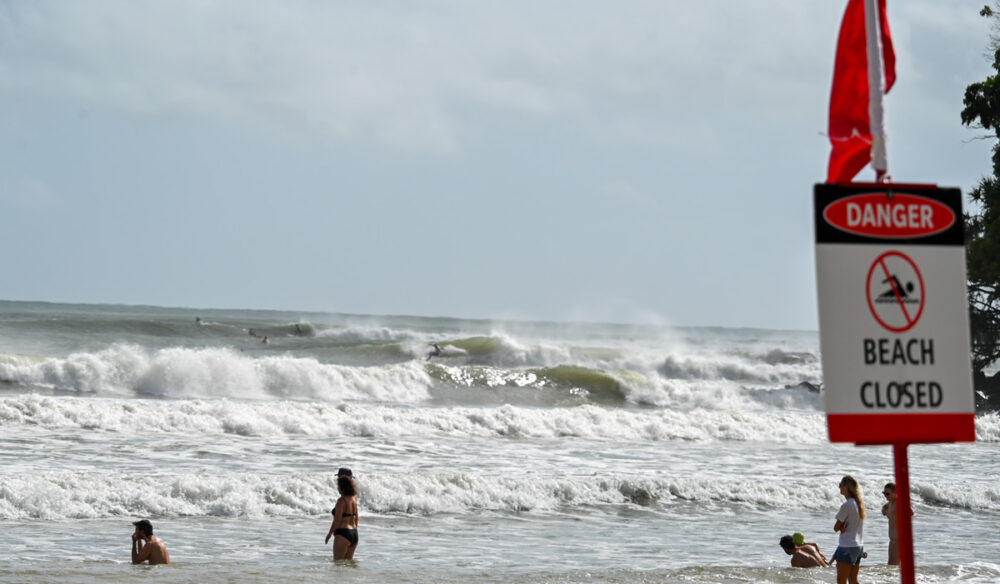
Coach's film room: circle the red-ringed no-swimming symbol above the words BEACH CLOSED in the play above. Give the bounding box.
[866,251,924,333]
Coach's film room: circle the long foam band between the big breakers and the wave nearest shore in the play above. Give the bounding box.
[0,395,825,443]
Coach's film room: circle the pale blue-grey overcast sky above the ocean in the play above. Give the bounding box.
[0,0,992,330]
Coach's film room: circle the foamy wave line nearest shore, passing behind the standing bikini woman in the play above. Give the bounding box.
[0,471,1000,520]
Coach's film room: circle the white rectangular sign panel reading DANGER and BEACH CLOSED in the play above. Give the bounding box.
[814,184,975,444]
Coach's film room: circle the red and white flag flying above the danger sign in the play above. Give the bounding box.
[826,0,896,183]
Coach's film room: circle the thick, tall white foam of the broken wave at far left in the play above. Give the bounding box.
[0,345,431,402]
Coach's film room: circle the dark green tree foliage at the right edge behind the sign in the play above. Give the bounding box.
[962,6,1000,374]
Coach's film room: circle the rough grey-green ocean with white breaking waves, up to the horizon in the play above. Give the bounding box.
[0,302,1000,584]
